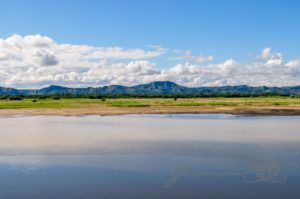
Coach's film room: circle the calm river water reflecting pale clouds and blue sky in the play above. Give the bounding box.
[0,115,300,199]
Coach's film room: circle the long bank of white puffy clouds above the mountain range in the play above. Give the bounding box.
[0,35,300,88]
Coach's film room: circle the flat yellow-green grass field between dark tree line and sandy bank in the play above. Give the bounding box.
[0,97,300,109]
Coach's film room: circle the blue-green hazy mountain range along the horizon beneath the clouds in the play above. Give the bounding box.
[0,81,300,95]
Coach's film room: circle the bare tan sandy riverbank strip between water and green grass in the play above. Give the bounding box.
[0,106,300,116]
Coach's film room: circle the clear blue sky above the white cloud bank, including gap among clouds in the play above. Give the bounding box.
[0,0,300,87]
